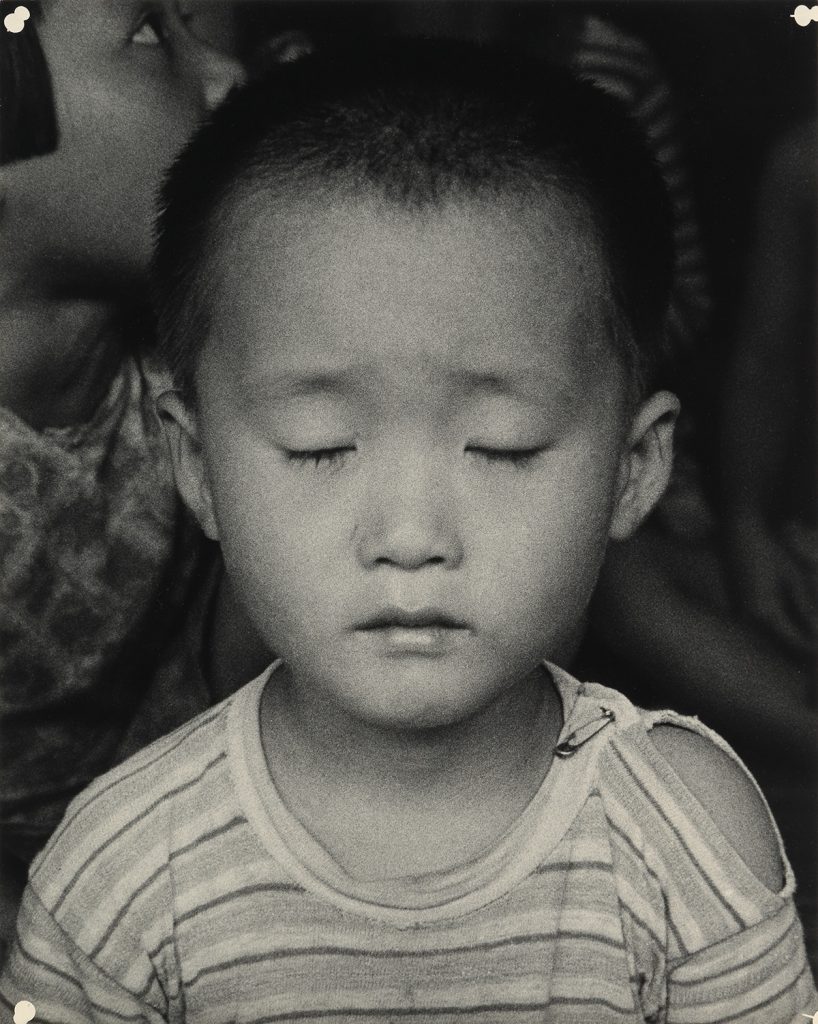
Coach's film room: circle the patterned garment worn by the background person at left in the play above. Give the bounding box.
[0,346,213,860]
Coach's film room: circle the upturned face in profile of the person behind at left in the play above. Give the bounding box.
[28,0,241,275]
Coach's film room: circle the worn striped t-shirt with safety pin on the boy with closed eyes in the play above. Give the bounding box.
[0,669,818,1024]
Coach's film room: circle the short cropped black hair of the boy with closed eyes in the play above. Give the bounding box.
[152,40,673,401]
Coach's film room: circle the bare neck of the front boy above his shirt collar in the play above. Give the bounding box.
[261,669,562,878]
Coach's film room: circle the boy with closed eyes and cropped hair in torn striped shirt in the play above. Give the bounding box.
[2,44,818,1024]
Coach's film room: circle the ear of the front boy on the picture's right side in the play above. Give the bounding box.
[608,391,680,541]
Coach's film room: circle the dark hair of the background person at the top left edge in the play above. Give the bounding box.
[0,0,59,164]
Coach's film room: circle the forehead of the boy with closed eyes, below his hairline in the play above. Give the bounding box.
[205,186,611,393]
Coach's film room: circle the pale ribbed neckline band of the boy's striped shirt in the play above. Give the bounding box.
[227,662,622,927]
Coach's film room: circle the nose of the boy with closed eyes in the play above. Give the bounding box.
[355,458,464,571]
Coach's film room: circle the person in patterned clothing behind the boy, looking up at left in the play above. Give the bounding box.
[0,0,274,958]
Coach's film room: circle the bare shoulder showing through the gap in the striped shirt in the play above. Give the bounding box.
[649,724,784,892]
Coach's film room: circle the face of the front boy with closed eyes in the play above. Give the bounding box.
[170,193,673,728]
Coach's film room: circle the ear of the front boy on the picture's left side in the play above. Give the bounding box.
[157,391,219,541]
